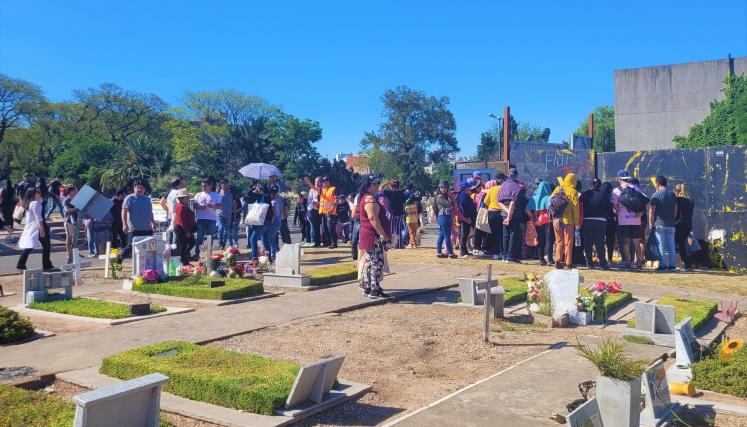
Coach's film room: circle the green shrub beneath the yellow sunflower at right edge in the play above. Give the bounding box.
[690,347,747,398]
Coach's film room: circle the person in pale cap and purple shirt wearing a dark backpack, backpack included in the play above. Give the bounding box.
[611,169,649,269]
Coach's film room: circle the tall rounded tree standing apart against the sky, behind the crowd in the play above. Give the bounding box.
[361,86,459,184]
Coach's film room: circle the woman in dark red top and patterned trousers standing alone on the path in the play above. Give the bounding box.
[358,175,392,299]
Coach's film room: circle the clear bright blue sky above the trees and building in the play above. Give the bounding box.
[0,0,747,156]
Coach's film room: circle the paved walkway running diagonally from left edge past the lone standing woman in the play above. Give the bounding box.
[0,263,480,373]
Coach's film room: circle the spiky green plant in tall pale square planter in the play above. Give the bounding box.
[577,338,646,427]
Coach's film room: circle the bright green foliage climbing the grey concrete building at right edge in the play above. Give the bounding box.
[674,74,747,148]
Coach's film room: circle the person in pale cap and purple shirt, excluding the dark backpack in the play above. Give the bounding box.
[611,169,643,269]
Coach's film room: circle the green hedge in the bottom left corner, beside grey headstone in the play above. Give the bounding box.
[0,383,75,427]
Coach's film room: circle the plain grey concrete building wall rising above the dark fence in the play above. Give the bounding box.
[615,57,747,151]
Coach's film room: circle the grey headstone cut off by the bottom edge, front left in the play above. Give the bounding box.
[73,373,169,427]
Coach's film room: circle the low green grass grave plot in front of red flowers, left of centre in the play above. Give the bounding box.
[132,275,264,300]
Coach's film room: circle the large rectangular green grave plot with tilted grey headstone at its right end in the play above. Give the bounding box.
[101,341,300,415]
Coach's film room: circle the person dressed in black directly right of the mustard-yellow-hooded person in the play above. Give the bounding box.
[581,178,612,270]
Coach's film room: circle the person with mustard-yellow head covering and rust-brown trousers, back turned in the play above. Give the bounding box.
[550,173,581,270]
